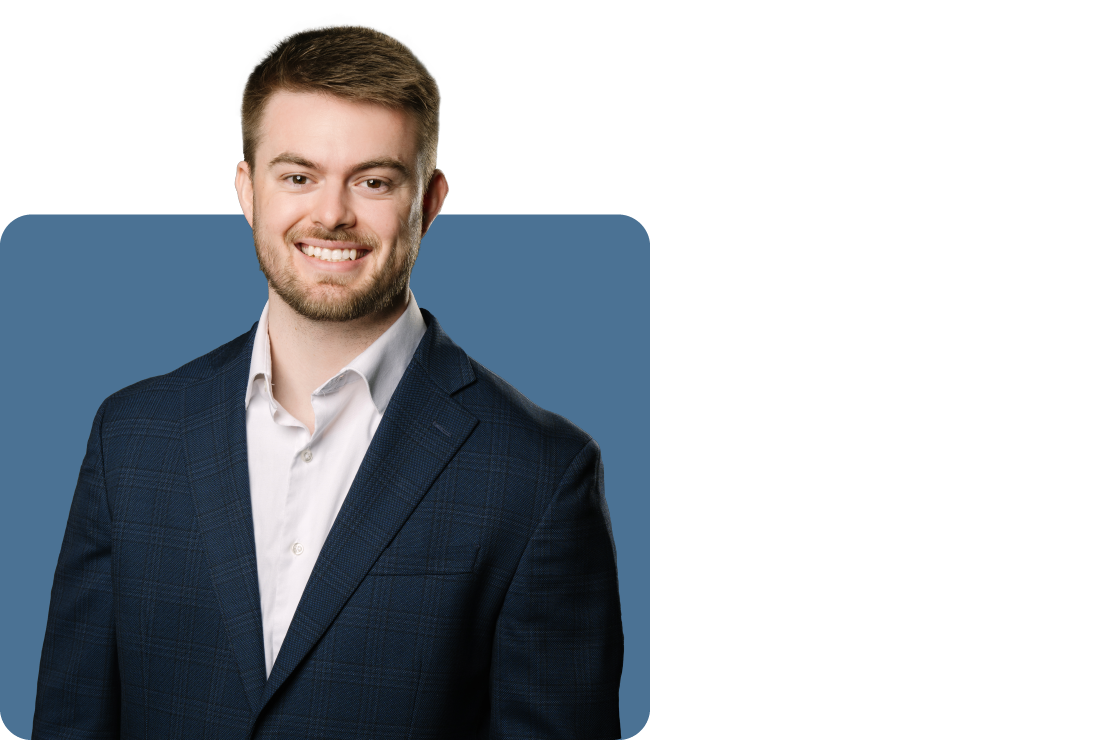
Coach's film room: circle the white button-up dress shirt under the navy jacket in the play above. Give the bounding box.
[244,293,425,678]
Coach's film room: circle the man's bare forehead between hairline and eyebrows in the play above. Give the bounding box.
[258,90,417,166]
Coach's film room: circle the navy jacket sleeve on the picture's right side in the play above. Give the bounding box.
[490,441,624,740]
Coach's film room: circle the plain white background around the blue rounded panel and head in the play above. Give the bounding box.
[0,0,1112,740]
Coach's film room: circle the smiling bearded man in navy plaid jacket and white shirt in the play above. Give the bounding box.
[33,16,623,739]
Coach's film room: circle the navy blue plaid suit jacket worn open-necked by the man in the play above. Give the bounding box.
[32,312,623,740]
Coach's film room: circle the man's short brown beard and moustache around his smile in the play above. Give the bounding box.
[252,220,418,322]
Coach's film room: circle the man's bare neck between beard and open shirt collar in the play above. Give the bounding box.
[267,283,409,434]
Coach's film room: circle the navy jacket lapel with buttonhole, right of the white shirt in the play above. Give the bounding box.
[265,312,478,704]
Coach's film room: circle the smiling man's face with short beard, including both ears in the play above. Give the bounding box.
[236,91,447,322]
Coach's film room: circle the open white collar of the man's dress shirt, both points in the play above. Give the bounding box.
[244,292,426,413]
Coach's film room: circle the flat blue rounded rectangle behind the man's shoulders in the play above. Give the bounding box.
[0,214,649,738]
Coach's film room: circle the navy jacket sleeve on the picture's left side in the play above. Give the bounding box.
[31,402,120,740]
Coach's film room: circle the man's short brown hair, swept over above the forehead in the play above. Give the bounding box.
[236,13,440,186]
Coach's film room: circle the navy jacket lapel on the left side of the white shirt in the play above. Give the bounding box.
[181,327,266,712]
